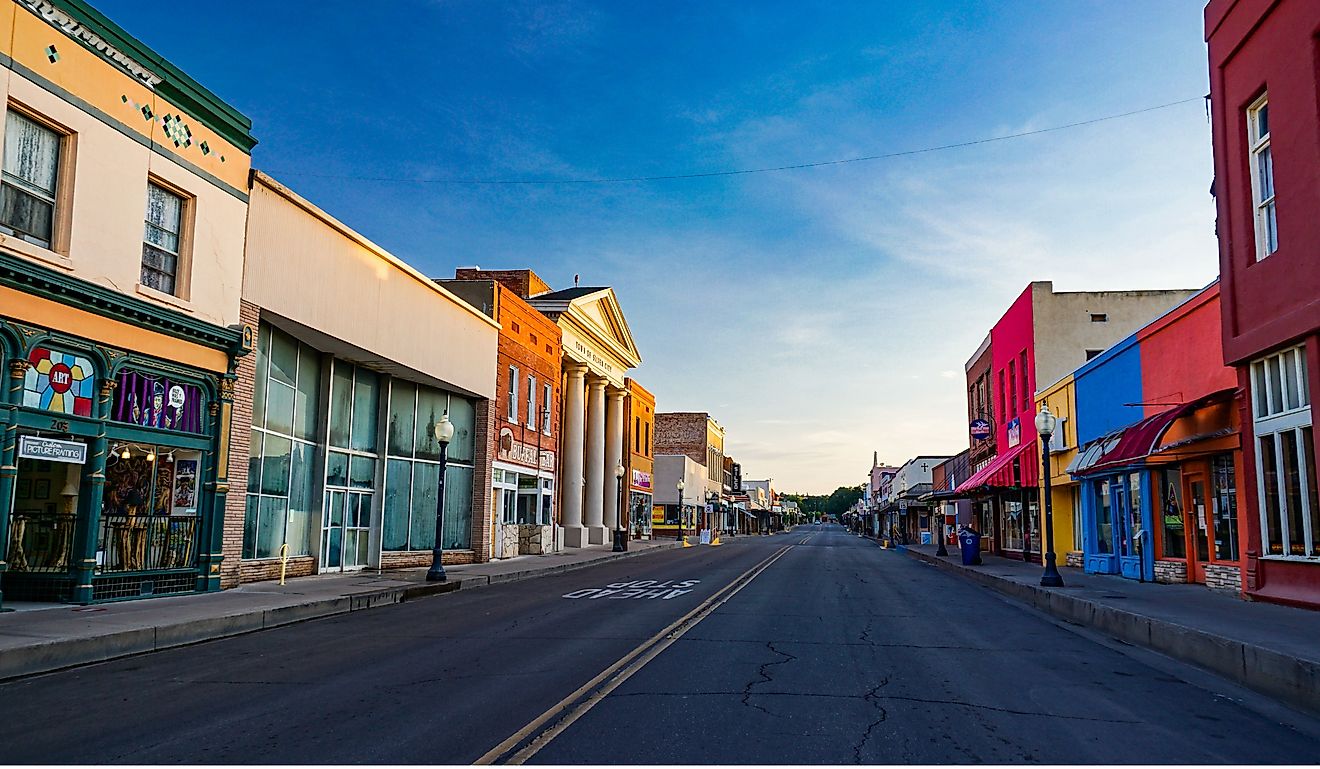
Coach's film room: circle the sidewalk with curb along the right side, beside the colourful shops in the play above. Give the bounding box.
[904,545,1320,712]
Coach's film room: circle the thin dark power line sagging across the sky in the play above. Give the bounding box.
[270,96,1204,185]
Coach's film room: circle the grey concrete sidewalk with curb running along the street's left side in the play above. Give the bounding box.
[0,539,678,681]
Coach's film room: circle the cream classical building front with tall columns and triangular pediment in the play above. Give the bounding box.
[527,286,642,547]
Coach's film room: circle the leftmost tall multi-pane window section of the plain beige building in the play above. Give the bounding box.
[243,324,320,558]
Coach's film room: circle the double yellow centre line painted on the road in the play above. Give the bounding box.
[473,545,793,765]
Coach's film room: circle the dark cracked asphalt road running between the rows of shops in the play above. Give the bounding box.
[0,526,1320,764]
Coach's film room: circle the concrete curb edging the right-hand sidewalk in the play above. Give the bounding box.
[907,550,1320,712]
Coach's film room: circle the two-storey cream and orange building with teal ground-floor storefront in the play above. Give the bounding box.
[0,0,256,603]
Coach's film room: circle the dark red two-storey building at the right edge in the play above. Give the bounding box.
[1205,0,1320,607]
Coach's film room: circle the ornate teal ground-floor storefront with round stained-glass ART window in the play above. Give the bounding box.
[0,265,242,604]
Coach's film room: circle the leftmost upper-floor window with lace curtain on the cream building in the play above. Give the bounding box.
[0,106,63,248]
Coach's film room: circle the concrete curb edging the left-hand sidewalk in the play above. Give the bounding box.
[0,542,678,681]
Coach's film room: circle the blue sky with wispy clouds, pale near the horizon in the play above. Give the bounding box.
[94,0,1217,493]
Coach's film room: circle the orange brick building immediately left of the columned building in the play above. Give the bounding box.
[438,276,562,558]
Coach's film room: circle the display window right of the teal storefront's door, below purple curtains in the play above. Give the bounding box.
[96,443,202,574]
